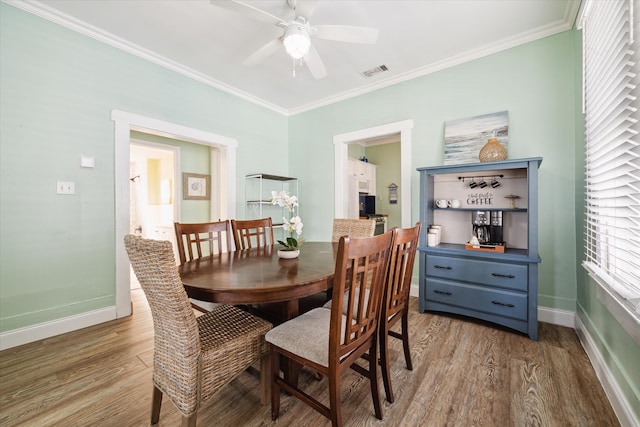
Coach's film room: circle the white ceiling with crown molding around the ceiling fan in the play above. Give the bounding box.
[10,0,580,114]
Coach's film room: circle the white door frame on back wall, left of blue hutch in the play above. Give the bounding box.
[333,120,413,228]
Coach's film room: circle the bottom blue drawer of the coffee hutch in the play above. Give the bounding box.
[425,277,528,321]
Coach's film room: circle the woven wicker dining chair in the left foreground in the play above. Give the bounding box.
[124,234,272,426]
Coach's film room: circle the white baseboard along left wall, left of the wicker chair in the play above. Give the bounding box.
[0,306,116,350]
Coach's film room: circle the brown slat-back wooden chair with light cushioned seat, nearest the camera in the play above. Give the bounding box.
[265,232,393,426]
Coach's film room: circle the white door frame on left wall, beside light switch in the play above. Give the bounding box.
[111,110,238,318]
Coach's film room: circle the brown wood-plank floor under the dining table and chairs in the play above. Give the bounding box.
[0,290,619,427]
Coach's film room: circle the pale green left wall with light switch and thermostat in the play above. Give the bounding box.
[0,3,289,332]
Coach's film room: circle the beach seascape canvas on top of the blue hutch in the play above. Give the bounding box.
[444,111,509,165]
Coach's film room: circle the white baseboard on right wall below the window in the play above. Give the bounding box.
[575,316,640,427]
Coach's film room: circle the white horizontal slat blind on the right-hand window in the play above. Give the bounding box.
[581,0,640,335]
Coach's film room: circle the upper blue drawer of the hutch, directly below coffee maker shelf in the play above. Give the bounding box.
[426,255,528,291]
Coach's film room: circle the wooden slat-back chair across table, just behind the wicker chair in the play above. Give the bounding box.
[173,220,232,313]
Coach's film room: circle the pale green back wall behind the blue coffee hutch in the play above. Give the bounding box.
[289,32,576,311]
